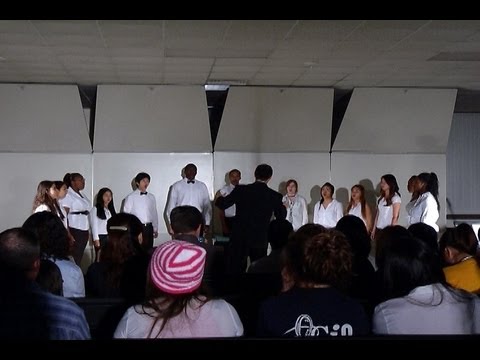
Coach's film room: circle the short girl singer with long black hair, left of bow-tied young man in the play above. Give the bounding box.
[90,187,117,260]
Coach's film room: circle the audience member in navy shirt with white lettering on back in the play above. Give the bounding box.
[257,229,370,337]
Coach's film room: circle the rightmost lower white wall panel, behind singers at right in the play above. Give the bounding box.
[332,153,447,228]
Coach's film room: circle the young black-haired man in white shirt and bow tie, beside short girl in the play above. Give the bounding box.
[123,172,158,250]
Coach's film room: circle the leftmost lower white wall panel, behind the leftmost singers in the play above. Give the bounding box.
[0,153,92,231]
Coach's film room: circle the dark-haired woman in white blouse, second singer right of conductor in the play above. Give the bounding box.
[313,182,343,228]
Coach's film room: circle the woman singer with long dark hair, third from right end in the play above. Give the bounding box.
[372,174,402,239]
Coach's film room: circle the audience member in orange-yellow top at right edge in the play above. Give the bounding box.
[439,223,480,294]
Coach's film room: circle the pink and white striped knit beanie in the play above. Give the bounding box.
[149,240,207,294]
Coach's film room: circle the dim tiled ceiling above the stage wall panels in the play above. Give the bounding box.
[0,20,480,90]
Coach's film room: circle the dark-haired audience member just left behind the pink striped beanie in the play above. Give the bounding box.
[85,213,149,305]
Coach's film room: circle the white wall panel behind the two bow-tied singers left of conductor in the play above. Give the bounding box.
[93,153,213,245]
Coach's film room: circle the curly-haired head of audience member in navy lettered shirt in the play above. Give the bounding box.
[285,230,352,290]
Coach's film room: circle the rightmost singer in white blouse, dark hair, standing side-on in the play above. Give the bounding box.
[408,172,440,232]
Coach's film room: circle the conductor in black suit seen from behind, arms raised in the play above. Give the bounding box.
[215,164,287,274]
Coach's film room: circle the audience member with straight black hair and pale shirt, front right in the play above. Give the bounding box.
[373,233,480,335]
